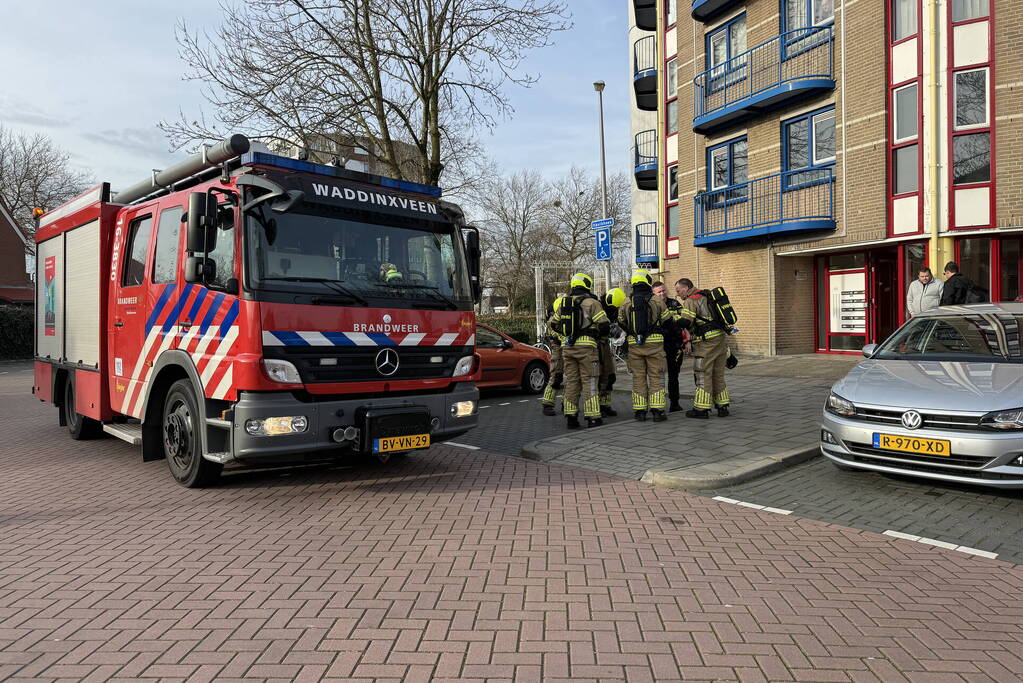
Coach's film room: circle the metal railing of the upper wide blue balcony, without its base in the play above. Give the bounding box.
[693,27,834,118]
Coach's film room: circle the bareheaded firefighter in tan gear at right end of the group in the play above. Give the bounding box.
[675,277,731,419]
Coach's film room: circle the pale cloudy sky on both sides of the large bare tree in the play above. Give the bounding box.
[0,0,631,189]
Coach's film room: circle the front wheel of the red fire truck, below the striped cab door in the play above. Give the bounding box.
[161,379,223,489]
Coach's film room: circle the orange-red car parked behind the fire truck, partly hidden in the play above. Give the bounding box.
[476,323,550,394]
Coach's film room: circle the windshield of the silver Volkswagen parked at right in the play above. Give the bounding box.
[874,313,1023,363]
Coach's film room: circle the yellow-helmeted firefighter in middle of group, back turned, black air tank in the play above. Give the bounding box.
[618,270,673,422]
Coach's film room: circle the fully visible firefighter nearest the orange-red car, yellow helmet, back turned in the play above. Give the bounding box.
[551,273,611,429]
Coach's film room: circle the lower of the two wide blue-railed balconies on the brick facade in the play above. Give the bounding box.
[693,167,835,246]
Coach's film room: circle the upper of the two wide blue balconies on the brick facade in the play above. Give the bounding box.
[693,27,835,135]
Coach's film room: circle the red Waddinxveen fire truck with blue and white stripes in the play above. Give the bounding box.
[33,135,480,487]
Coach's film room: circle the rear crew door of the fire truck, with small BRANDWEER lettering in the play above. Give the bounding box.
[107,203,157,417]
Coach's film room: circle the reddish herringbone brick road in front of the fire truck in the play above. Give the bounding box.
[0,370,1023,681]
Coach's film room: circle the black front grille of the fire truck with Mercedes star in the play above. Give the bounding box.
[263,347,473,383]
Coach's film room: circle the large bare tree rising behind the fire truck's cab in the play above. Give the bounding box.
[162,0,569,192]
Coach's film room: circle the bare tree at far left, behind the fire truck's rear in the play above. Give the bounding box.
[0,125,93,244]
